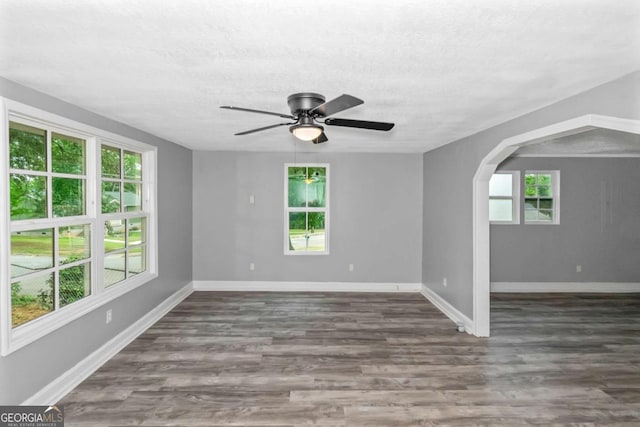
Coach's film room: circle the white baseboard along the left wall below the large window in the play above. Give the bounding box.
[22,283,193,405]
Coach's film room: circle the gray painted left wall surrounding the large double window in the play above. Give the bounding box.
[0,78,192,404]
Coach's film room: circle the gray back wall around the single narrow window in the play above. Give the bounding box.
[193,151,422,283]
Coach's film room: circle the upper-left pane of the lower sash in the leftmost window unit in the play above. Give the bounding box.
[11,228,53,277]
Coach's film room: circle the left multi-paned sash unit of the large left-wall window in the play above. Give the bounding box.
[9,119,93,328]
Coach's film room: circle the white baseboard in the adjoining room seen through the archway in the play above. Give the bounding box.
[491,282,640,293]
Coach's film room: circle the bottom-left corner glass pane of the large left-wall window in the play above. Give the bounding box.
[11,273,54,328]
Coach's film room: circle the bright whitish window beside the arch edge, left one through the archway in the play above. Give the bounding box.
[489,171,520,224]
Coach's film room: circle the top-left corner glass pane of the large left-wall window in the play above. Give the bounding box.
[9,122,47,171]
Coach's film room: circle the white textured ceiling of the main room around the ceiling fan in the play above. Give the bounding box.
[0,0,640,152]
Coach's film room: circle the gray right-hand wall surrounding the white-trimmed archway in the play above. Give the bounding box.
[422,72,640,318]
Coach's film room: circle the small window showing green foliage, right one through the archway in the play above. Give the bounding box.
[524,170,560,224]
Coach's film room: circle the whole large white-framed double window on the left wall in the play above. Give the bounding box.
[0,98,157,355]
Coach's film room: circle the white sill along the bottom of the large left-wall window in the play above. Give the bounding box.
[2,272,158,356]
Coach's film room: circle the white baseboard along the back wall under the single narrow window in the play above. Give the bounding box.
[193,280,422,292]
